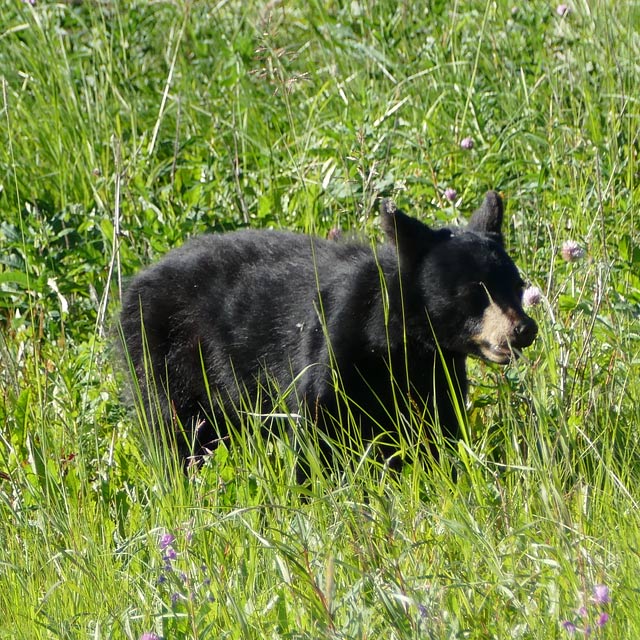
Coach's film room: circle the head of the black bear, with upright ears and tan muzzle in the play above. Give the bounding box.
[382,191,538,364]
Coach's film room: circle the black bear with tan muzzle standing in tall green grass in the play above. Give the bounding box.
[121,192,537,470]
